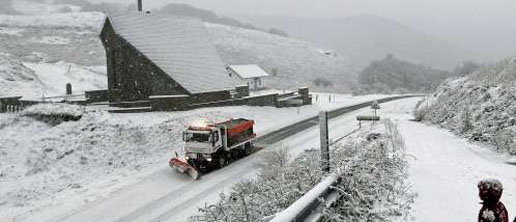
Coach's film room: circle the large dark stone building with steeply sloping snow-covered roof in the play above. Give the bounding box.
[100,12,245,104]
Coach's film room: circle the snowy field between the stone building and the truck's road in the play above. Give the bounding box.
[0,96,394,222]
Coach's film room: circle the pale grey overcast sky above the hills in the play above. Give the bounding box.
[90,0,516,58]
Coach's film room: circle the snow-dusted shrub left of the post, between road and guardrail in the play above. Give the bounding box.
[192,148,322,221]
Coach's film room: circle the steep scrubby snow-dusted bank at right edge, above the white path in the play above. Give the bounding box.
[416,58,516,155]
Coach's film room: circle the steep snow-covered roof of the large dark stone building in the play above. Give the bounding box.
[108,12,240,94]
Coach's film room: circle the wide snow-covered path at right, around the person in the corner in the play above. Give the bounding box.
[398,118,516,222]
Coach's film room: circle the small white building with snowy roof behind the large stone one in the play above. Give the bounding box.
[227,64,269,90]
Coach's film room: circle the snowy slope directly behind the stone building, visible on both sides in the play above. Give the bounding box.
[0,5,356,98]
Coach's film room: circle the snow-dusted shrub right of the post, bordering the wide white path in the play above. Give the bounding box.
[323,121,415,221]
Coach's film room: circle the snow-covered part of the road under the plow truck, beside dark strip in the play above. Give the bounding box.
[26,98,419,222]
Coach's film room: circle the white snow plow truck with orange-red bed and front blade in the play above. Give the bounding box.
[169,118,256,179]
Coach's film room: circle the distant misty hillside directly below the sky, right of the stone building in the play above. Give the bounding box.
[235,14,483,70]
